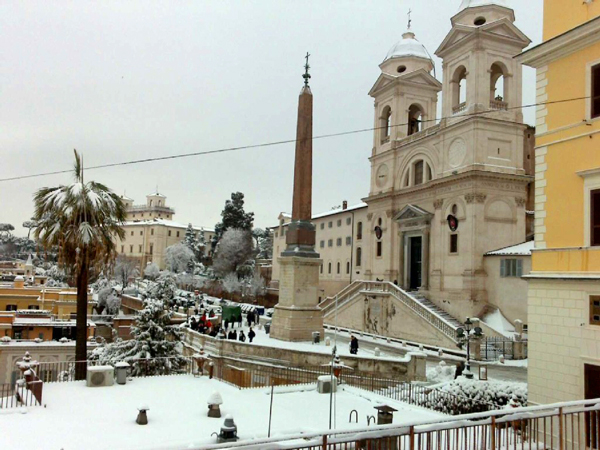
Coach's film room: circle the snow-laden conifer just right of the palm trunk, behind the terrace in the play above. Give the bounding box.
[89,298,186,376]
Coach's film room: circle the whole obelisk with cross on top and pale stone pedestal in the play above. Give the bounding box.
[271,54,323,341]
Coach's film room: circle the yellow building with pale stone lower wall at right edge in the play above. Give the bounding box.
[519,0,600,404]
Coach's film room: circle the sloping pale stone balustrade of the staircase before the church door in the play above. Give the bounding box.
[319,280,461,343]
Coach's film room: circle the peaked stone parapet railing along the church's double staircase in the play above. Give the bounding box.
[321,280,457,342]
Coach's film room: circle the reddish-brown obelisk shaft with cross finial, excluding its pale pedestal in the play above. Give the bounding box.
[281,53,319,258]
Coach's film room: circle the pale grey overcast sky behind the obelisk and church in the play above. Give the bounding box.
[0,0,543,235]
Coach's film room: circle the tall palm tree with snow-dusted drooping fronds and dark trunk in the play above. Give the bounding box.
[33,150,125,380]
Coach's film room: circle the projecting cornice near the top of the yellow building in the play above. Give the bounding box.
[515,16,600,69]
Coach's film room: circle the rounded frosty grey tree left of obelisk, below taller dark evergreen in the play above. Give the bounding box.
[213,228,254,277]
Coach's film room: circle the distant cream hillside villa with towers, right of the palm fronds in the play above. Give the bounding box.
[117,192,215,270]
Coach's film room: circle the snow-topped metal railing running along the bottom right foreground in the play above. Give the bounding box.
[196,399,600,450]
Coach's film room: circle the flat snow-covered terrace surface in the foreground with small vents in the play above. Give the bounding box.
[0,375,442,450]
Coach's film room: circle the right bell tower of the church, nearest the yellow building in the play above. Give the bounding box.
[435,0,531,123]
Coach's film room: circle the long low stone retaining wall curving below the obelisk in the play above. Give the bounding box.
[184,329,426,381]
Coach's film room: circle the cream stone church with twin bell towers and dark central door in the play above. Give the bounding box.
[273,0,535,328]
